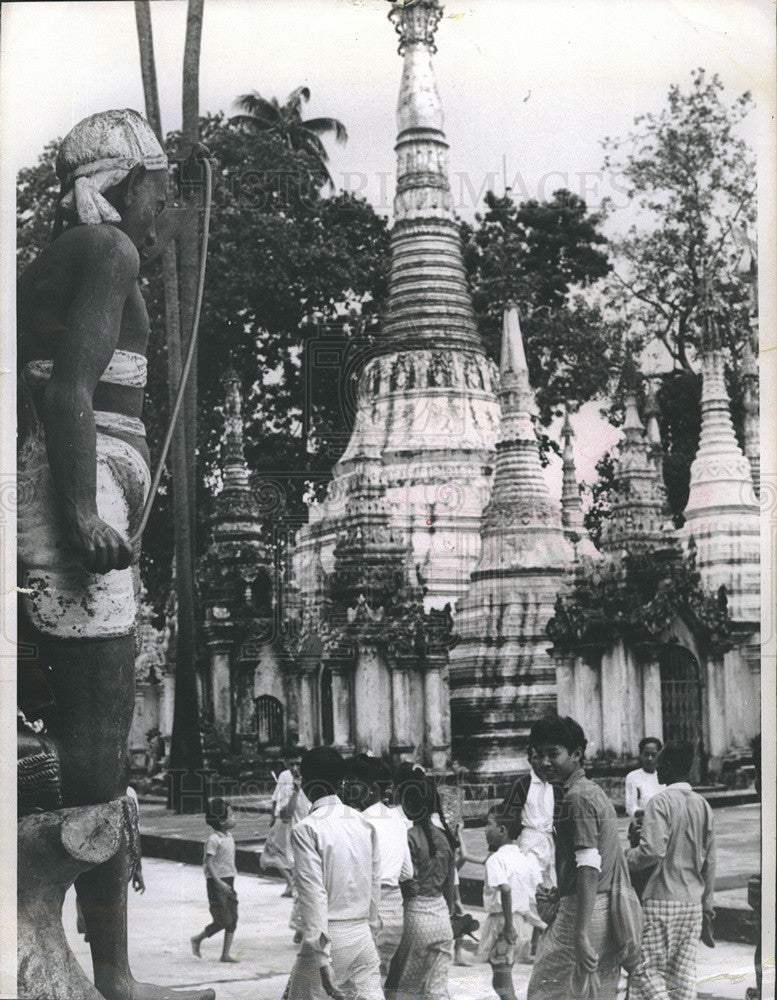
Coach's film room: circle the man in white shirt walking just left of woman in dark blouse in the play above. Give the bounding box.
[346,754,413,981]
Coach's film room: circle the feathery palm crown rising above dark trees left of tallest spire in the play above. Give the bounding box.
[231,87,348,188]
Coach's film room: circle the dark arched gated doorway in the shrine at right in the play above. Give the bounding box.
[659,646,707,785]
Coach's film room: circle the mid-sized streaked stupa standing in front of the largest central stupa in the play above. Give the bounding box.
[450,304,574,775]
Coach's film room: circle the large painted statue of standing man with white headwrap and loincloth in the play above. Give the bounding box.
[17,110,214,1000]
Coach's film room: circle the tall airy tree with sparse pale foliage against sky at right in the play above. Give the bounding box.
[604,69,756,516]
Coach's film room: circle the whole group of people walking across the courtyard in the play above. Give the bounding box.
[192,716,715,1000]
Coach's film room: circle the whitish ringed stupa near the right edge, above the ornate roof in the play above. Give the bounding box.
[682,313,761,622]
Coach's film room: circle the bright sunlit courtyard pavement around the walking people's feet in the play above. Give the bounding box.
[64,858,773,1000]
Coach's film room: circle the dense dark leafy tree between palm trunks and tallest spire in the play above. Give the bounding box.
[139,115,388,608]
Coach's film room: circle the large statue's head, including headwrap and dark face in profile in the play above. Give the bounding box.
[56,108,168,255]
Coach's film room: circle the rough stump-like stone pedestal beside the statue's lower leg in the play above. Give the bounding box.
[17,799,123,1000]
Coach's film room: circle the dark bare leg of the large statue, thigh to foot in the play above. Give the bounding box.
[42,635,215,1000]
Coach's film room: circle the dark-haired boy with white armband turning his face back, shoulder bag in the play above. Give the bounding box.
[527,715,623,1000]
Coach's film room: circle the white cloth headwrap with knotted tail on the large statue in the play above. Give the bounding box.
[57,108,167,224]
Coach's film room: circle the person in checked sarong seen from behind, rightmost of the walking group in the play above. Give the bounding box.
[627,742,715,1000]
